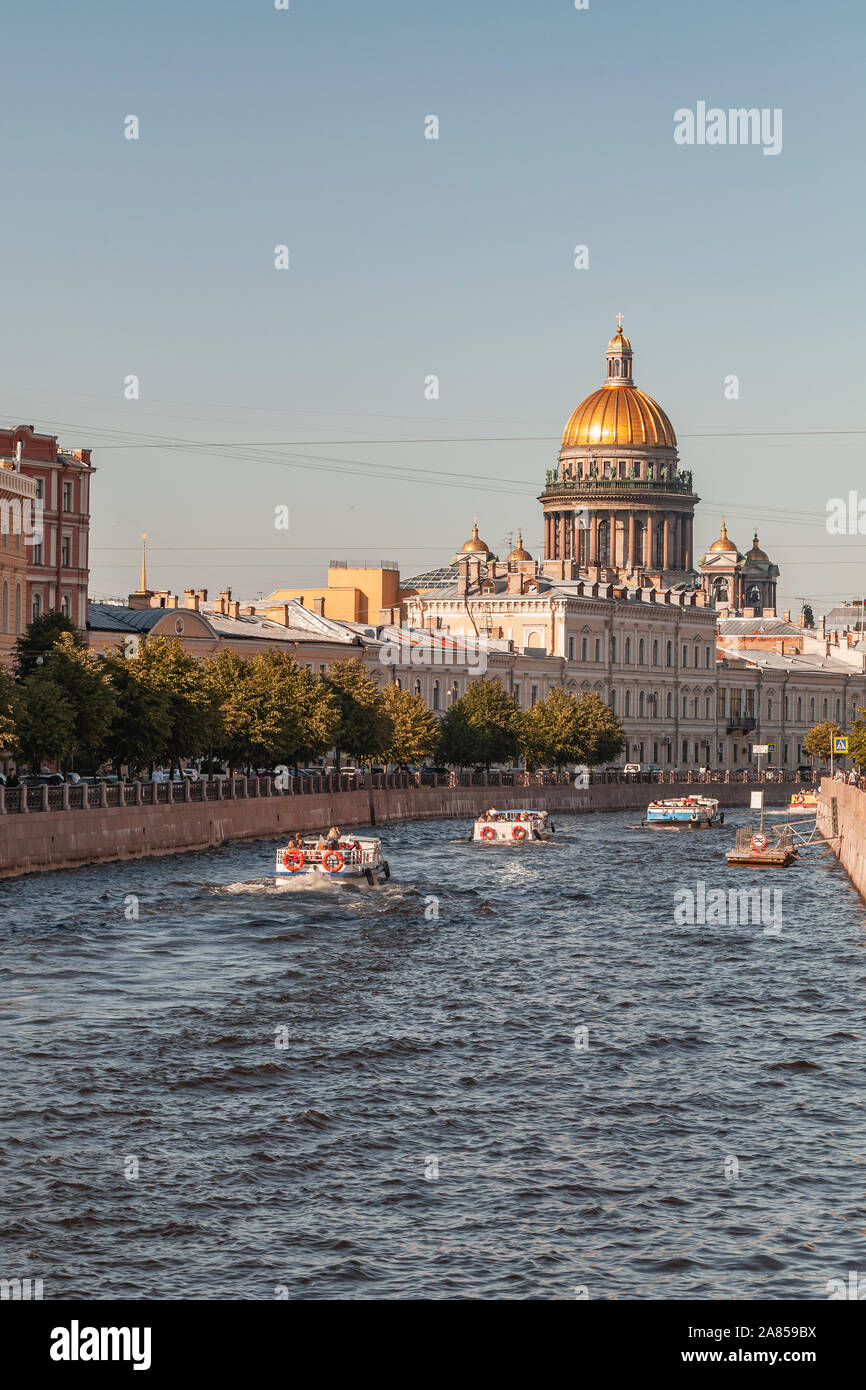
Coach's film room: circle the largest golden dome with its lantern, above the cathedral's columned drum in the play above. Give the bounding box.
[563,327,677,449]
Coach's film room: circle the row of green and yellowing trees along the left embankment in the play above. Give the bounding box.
[0,613,624,773]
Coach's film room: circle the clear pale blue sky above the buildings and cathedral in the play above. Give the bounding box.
[0,0,866,610]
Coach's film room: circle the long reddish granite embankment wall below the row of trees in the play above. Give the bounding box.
[0,783,796,878]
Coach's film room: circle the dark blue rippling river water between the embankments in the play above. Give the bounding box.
[0,812,866,1300]
